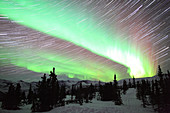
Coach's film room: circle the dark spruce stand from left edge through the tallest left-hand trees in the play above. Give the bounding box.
[1,68,66,112]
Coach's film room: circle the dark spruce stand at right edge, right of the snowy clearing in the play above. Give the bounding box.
[136,66,170,113]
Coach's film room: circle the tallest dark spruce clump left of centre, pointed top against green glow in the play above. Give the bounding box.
[32,68,65,111]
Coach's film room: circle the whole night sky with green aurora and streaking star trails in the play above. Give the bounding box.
[0,0,170,81]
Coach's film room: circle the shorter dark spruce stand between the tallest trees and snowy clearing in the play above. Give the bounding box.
[69,75,125,105]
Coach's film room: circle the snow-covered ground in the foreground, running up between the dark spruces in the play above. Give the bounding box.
[0,88,155,113]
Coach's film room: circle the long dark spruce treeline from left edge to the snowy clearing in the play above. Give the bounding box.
[1,68,127,112]
